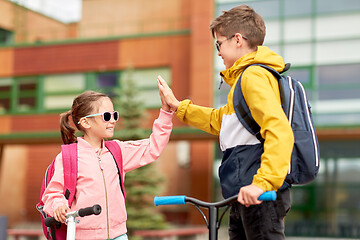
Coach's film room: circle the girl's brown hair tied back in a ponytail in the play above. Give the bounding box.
[60,91,108,144]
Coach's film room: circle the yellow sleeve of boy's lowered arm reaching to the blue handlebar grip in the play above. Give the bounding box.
[241,66,294,191]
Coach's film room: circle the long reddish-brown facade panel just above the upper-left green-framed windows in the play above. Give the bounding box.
[14,41,118,75]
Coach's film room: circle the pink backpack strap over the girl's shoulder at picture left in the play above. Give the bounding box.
[61,143,78,207]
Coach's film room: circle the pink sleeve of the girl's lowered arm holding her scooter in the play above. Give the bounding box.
[42,153,68,216]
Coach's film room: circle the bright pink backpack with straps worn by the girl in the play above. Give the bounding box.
[36,141,125,240]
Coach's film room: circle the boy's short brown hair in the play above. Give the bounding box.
[210,5,266,48]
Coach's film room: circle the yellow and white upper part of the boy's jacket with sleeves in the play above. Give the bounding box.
[176,46,294,191]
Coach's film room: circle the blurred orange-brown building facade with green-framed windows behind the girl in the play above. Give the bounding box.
[0,0,214,226]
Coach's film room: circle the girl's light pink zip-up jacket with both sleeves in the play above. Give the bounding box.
[42,110,174,239]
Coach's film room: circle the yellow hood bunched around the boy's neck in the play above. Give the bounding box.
[220,46,285,86]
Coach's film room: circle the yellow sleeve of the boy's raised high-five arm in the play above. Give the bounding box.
[176,100,226,135]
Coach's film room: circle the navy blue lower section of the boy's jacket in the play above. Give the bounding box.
[219,144,263,198]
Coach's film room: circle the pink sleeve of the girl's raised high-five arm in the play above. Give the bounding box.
[116,109,174,173]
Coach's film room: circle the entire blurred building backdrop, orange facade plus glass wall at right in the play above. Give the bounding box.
[0,0,360,237]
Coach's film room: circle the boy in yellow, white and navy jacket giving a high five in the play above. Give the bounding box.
[158,5,294,240]
